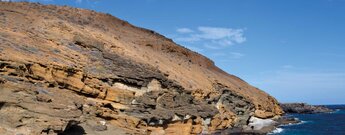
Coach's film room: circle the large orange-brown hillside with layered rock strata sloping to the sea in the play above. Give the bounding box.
[0,2,282,135]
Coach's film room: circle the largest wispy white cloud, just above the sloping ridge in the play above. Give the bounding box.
[175,26,246,48]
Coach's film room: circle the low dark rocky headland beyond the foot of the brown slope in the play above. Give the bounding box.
[280,103,333,114]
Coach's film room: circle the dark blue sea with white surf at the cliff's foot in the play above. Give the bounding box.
[273,105,345,135]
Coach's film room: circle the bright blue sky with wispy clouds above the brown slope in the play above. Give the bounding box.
[14,0,345,104]
